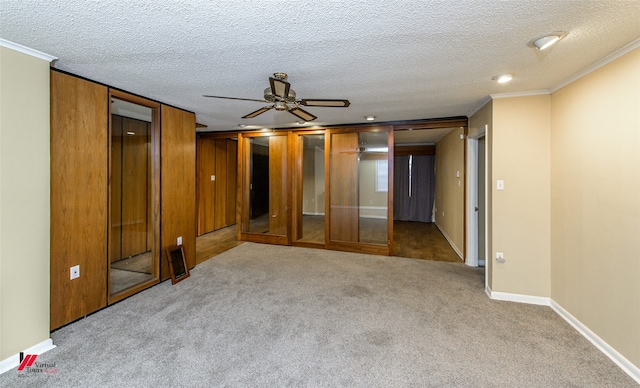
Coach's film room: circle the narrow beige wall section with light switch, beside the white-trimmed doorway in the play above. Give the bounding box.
[489,94,551,301]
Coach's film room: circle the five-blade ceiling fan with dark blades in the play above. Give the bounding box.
[203,73,350,121]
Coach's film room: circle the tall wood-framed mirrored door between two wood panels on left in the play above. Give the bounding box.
[109,94,160,302]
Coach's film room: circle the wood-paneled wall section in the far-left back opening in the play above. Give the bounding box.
[196,136,238,236]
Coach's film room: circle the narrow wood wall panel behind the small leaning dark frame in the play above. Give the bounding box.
[160,105,196,280]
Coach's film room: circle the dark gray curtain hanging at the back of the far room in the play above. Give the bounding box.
[393,155,436,222]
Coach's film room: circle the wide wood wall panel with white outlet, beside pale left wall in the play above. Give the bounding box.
[50,71,109,329]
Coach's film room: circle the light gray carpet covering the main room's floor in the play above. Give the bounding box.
[0,243,635,387]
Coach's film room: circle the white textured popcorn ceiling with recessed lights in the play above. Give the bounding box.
[0,0,640,131]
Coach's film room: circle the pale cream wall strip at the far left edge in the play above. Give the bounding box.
[0,41,55,366]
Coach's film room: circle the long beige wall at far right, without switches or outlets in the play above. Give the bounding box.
[551,44,640,370]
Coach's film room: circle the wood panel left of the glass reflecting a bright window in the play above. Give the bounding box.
[330,133,358,242]
